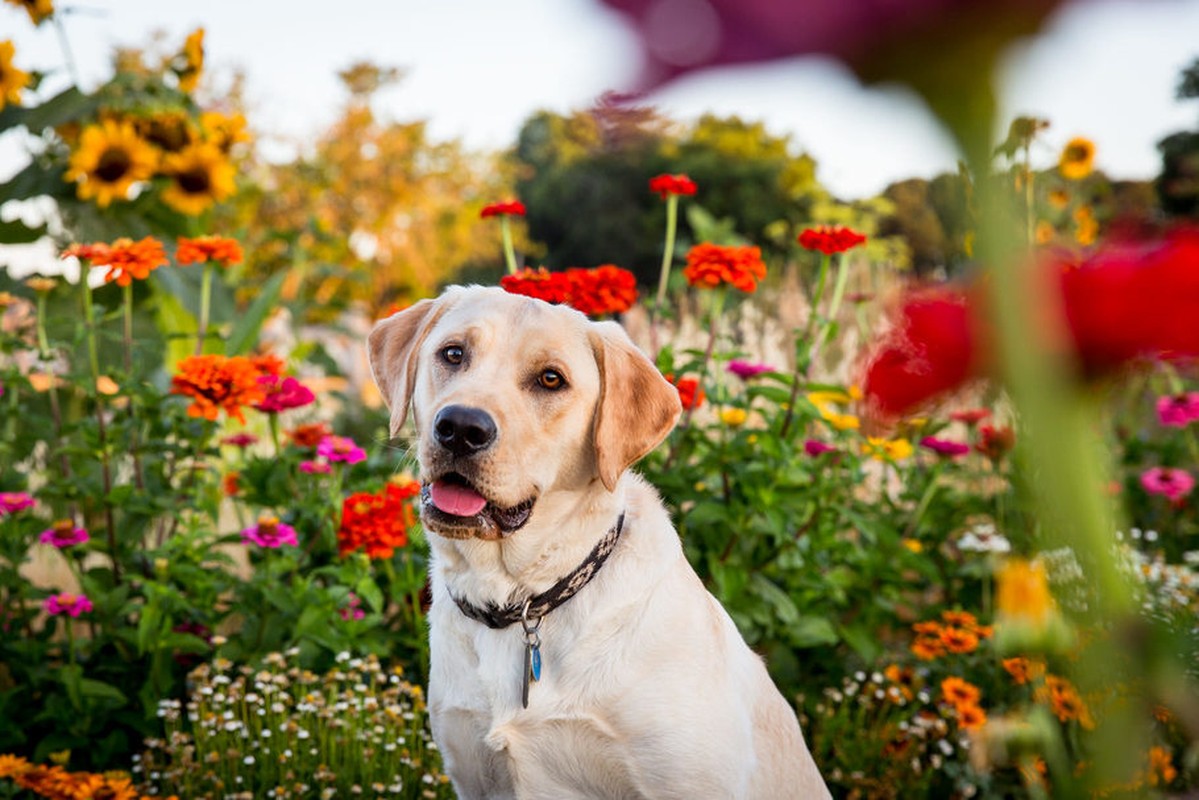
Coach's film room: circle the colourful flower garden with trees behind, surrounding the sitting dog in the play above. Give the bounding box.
[0,0,1199,800]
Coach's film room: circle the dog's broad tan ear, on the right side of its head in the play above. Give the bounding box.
[591,323,682,492]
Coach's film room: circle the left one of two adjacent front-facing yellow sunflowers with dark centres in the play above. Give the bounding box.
[66,120,157,209]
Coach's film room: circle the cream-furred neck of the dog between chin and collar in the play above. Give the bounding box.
[429,480,625,606]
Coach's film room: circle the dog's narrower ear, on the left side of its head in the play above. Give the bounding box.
[367,300,445,437]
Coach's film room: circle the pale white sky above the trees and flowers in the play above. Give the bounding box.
[7,0,1199,198]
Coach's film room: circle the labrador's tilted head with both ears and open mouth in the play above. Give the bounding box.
[368,287,681,539]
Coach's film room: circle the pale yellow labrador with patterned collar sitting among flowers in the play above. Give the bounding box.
[369,287,829,800]
